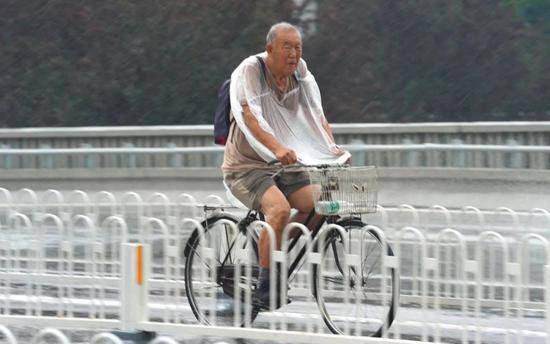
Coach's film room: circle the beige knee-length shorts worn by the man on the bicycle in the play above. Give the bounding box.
[223,169,310,211]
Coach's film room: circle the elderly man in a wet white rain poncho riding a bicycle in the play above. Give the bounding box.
[222,23,349,306]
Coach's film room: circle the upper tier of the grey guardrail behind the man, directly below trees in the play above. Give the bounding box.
[0,122,550,148]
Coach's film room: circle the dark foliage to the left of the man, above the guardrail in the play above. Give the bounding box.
[0,0,302,126]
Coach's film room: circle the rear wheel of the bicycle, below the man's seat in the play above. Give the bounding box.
[185,214,258,326]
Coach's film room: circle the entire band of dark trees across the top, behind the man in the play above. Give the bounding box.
[0,0,550,127]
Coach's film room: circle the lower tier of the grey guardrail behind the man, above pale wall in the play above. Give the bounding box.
[0,142,550,169]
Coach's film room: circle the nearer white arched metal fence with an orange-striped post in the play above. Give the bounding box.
[0,208,550,343]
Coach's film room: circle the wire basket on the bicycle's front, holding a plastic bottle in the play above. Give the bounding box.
[308,166,378,215]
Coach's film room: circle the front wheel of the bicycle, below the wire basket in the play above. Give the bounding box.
[313,220,398,337]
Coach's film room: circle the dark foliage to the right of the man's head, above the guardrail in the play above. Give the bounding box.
[312,0,550,122]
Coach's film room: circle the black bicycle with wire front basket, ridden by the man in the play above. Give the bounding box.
[184,165,399,337]
